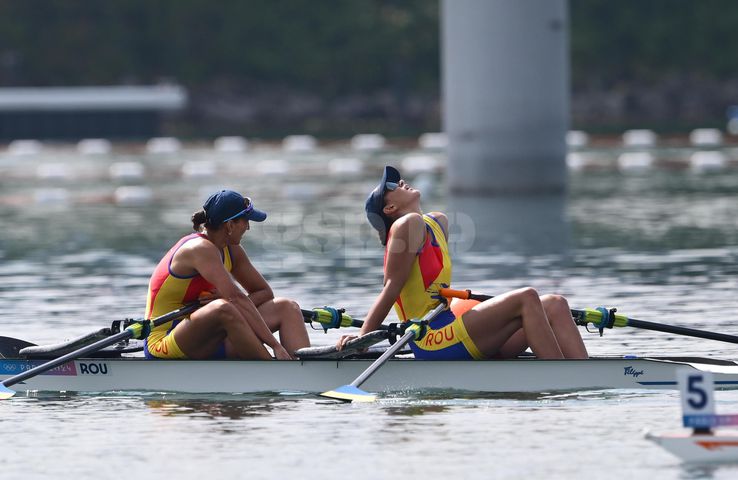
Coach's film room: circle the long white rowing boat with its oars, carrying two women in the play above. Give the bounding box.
[0,302,738,401]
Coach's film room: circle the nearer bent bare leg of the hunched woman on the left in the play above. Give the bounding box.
[172,299,272,360]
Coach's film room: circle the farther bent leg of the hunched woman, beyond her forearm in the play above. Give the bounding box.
[259,297,310,354]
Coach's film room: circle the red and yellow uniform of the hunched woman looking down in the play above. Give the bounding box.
[144,233,232,358]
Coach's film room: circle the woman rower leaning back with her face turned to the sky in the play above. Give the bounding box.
[336,166,587,360]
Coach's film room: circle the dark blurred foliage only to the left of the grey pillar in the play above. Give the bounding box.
[0,0,438,95]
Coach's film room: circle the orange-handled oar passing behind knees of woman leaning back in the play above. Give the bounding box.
[441,288,738,343]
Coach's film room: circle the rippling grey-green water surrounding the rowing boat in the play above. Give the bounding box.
[0,144,738,479]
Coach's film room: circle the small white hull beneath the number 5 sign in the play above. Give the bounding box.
[646,432,738,463]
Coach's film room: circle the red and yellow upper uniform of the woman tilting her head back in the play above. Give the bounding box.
[384,215,451,322]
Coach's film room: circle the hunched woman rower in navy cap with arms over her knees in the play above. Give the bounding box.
[144,190,310,360]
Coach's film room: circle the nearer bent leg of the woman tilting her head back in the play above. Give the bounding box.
[462,288,564,358]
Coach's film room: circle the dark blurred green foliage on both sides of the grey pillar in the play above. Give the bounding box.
[0,0,738,108]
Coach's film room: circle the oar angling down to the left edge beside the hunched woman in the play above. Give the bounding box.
[0,300,202,400]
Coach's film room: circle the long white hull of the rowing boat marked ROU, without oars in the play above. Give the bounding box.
[0,356,738,393]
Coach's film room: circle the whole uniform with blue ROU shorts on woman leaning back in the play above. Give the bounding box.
[385,215,484,360]
